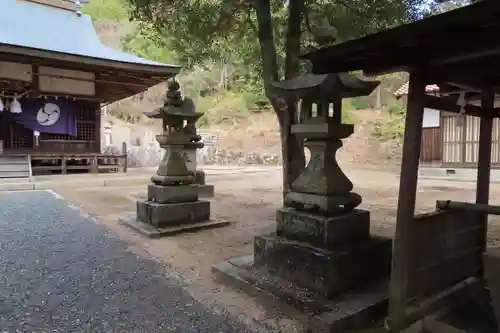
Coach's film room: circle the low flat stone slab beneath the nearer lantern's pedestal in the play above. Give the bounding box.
[212,255,389,333]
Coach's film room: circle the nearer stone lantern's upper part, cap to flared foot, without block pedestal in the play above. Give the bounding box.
[275,73,379,215]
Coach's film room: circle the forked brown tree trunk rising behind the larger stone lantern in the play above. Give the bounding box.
[254,0,305,195]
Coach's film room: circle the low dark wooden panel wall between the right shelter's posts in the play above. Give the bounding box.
[388,209,485,329]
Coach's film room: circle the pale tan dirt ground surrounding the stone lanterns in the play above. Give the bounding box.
[51,165,500,332]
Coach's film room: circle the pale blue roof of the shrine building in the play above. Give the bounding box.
[0,0,177,72]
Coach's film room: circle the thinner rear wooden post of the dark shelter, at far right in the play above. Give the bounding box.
[476,89,495,256]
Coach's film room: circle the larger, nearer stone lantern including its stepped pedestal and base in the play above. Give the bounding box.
[214,73,392,327]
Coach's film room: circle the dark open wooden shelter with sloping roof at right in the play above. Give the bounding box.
[304,0,500,331]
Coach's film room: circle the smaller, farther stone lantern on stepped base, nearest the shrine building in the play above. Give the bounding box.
[122,81,227,237]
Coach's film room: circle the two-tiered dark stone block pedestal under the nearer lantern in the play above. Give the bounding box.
[254,208,392,298]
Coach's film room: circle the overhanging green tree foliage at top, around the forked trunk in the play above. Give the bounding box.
[125,0,425,68]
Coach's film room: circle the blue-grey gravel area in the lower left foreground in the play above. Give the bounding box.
[0,192,260,333]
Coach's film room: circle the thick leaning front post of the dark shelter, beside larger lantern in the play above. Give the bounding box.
[387,72,425,331]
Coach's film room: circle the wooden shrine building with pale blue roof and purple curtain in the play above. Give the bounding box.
[0,0,180,177]
